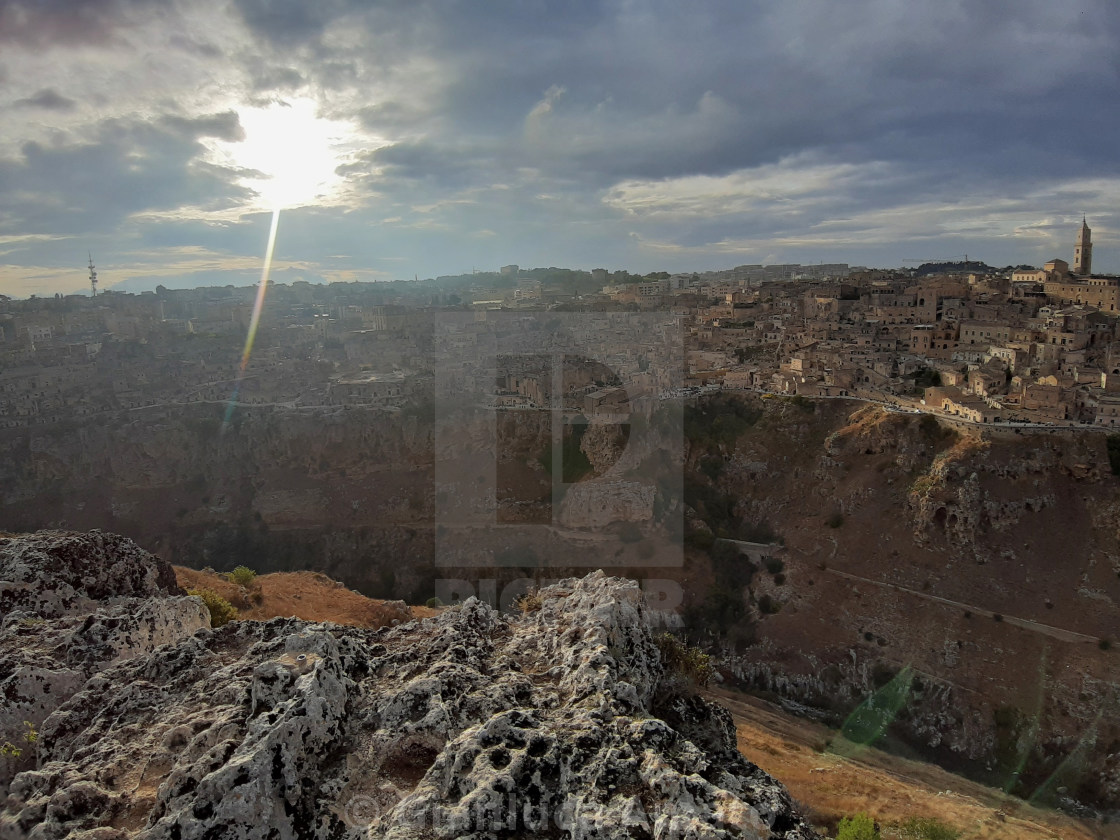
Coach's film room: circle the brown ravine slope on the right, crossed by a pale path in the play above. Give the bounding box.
[687,400,1120,809]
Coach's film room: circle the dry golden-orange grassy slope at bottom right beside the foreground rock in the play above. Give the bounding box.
[709,689,1106,840]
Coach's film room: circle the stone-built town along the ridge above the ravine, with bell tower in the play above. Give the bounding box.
[0,223,1120,428]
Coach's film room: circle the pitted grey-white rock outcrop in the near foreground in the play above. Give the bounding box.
[0,534,814,840]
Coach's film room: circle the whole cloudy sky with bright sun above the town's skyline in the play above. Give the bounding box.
[0,0,1120,297]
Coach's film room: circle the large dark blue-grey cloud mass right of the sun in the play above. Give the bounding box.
[297,2,1117,197]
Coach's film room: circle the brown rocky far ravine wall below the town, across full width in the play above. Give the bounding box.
[8,395,1120,802]
